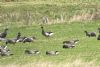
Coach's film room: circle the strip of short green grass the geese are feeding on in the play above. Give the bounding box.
[0,21,100,64]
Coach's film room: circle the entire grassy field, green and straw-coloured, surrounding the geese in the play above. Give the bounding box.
[0,0,100,67]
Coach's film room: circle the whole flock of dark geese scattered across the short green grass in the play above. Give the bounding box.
[0,26,100,56]
